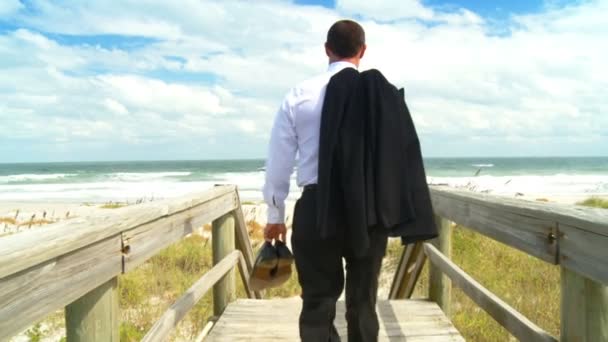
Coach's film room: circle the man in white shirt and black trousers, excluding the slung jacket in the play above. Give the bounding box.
[264,20,388,342]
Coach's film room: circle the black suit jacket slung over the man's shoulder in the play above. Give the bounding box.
[317,68,437,255]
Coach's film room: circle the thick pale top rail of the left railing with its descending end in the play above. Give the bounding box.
[0,185,260,340]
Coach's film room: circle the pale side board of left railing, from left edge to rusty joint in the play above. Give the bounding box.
[0,235,122,341]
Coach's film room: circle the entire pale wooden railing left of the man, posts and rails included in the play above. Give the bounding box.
[0,186,260,341]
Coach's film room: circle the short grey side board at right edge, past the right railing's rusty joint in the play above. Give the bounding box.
[559,223,608,285]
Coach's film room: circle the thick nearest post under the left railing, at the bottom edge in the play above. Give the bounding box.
[65,277,120,342]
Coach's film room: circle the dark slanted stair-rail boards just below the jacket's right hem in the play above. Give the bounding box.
[389,243,426,299]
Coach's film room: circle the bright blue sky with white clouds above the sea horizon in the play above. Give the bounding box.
[0,0,608,163]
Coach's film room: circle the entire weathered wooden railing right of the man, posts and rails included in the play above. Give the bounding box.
[390,187,608,342]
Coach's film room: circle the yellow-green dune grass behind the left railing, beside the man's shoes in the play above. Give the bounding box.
[119,222,300,341]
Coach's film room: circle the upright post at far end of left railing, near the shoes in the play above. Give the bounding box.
[211,213,236,316]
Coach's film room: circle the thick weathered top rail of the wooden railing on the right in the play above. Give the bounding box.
[431,187,608,285]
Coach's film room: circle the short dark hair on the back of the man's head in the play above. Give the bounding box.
[327,20,365,58]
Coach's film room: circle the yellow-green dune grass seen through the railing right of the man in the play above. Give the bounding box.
[387,226,560,341]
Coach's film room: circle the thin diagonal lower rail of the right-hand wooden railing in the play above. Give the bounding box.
[424,243,557,341]
